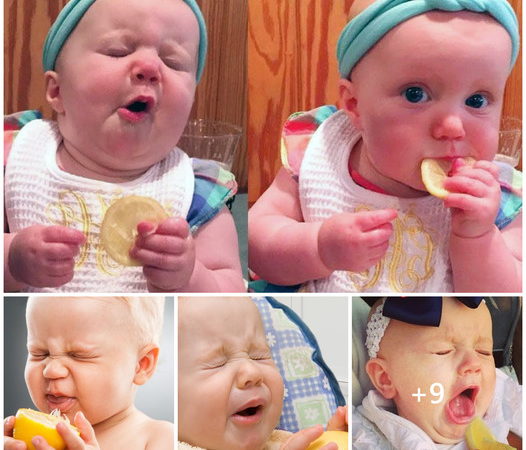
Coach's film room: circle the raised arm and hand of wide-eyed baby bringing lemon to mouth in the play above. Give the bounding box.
[445,161,522,292]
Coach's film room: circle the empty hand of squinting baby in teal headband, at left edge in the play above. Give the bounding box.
[7,225,86,287]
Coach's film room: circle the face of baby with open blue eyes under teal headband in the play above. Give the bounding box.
[341,12,511,197]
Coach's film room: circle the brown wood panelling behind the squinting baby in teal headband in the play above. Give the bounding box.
[4,0,247,191]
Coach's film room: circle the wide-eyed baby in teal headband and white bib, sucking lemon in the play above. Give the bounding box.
[249,0,522,292]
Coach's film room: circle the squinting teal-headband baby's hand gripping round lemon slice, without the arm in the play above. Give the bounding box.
[130,217,195,292]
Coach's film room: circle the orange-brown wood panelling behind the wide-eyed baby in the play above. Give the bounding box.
[248,0,522,204]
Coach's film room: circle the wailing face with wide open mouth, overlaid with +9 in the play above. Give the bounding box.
[378,298,495,444]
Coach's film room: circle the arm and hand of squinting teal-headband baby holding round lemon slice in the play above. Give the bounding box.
[130,208,245,292]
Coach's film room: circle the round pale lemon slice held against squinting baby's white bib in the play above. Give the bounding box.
[100,195,168,266]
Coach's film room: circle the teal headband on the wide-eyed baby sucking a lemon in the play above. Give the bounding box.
[336,0,520,78]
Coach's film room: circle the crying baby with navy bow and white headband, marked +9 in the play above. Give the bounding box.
[353,297,522,450]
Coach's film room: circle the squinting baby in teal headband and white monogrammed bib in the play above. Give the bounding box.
[4,0,245,292]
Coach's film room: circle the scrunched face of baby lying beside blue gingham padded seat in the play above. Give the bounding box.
[178,298,283,450]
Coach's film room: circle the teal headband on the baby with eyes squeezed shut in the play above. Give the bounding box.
[42,0,207,82]
